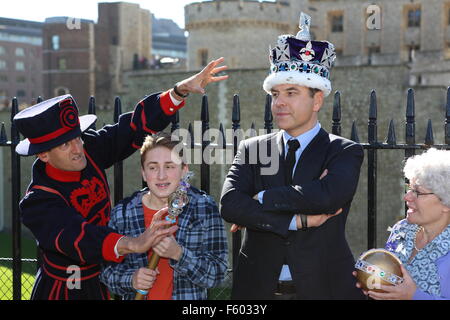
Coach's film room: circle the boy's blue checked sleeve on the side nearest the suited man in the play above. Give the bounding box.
[170,196,228,288]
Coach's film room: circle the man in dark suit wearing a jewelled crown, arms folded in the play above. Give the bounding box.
[221,14,364,299]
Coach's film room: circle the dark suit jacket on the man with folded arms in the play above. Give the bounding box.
[221,129,364,299]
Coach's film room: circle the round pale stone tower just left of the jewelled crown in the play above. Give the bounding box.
[185,0,304,70]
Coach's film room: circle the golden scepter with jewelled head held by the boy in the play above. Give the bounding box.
[134,171,194,300]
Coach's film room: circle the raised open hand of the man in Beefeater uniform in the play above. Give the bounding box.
[171,57,228,100]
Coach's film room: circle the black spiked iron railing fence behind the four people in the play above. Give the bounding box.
[0,87,450,300]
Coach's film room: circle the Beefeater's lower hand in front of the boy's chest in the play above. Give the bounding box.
[117,208,178,255]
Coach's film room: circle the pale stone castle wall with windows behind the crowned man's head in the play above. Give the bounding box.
[185,0,450,70]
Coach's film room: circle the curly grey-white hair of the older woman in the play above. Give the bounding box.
[403,148,450,207]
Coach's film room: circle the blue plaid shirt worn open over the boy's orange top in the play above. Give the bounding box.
[100,187,228,300]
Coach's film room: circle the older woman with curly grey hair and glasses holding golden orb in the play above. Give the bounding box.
[366,149,450,300]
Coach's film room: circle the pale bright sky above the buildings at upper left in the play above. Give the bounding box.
[0,0,199,28]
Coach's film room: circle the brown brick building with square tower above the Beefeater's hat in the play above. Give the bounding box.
[43,2,151,110]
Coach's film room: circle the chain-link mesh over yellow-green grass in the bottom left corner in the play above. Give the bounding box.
[0,258,37,300]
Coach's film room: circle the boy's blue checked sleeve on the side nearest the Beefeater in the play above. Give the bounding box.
[100,204,136,296]
